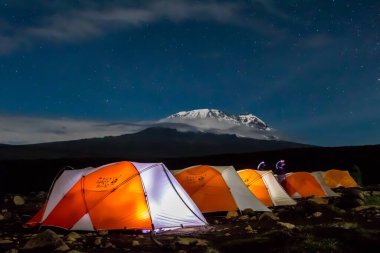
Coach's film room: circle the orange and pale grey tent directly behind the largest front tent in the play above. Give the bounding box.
[172,165,270,213]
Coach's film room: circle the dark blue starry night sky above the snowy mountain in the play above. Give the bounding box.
[0,0,380,146]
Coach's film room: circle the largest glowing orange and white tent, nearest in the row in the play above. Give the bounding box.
[27,162,207,230]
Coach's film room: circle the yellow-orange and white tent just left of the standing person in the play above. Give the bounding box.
[238,169,296,206]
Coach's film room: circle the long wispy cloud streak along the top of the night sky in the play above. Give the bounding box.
[0,0,296,54]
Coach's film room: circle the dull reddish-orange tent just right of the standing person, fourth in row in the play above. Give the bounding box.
[281,172,338,198]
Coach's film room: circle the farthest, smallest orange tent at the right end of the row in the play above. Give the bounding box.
[313,169,359,188]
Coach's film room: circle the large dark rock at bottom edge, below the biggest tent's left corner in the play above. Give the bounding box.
[23,229,70,251]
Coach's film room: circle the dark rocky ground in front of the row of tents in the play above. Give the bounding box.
[0,186,380,253]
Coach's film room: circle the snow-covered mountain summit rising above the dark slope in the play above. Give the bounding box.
[157,109,278,140]
